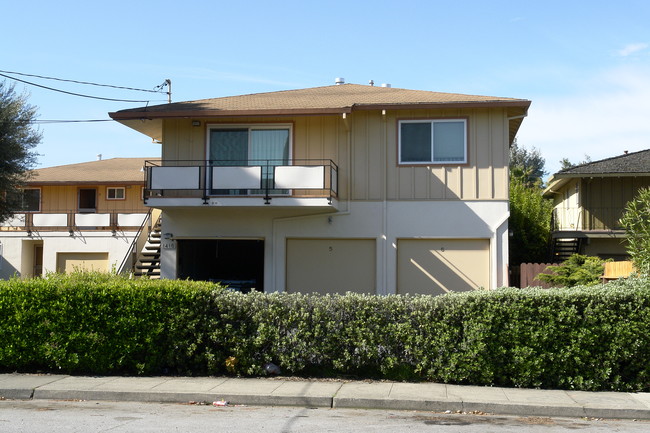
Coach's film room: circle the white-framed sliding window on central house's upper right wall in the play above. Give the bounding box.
[399,119,467,164]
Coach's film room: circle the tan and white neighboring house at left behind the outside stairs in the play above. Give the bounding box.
[0,158,157,279]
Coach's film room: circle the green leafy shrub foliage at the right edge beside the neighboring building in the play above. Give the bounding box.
[621,188,650,276]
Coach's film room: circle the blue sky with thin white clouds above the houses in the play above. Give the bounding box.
[0,0,650,173]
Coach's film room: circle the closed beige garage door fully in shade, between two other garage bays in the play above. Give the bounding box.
[286,239,376,294]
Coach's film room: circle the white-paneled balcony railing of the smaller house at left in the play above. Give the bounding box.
[0,211,147,234]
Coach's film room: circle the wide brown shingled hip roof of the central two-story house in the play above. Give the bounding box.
[109,84,530,120]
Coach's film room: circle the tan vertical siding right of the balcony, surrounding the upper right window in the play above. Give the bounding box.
[350,109,508,200]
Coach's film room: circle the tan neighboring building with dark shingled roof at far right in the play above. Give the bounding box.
[544,150,650,260]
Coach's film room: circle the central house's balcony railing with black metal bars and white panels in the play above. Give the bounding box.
[144,159,338,204]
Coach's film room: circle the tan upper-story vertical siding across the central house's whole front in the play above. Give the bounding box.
[162,109,508,200]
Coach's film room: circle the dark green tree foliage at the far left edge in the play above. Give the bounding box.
[0,82,41,221]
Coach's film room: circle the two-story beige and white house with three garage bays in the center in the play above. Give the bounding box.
[110,84,530,294]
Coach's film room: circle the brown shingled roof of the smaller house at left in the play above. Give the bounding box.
[27,158,154,185]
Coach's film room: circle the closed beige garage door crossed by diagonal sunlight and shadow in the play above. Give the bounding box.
[397,239,490,295]
